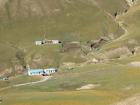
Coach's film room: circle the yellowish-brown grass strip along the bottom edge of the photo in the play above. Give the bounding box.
[2,91,126,105]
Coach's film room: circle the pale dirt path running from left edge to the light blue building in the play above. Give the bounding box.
[0,76,52,91]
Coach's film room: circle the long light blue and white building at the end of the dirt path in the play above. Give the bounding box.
[28,68,57,76]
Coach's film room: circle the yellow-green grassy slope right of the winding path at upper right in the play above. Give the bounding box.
[103,2,140,50]
